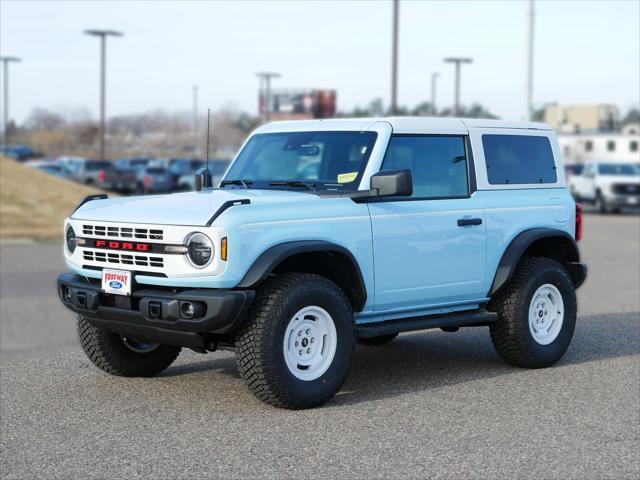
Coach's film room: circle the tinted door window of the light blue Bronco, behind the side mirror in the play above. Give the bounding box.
[382,135,469,198]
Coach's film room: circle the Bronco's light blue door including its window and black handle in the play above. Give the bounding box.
[369,135,486,318]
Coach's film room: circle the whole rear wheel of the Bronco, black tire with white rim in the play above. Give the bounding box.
[490,257,577,368]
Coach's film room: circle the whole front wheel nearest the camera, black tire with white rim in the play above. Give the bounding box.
[236,273,355,409]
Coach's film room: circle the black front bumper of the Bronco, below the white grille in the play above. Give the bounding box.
[58,273,255,349]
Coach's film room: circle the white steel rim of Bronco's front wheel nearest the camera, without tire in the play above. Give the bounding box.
[283,306,338,382]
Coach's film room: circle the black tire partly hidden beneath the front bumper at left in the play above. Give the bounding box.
[78,315,180,377]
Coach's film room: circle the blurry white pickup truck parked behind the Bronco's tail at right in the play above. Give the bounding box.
[568,161,640,213]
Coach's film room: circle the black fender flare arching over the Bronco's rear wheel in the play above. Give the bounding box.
[489,227,584,297]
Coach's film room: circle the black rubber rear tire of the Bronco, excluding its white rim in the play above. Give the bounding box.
[489,257,577,368]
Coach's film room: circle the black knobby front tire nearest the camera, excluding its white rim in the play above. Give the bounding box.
[235,273,355,409]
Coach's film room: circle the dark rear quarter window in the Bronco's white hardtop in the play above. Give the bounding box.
[482,135,558,185]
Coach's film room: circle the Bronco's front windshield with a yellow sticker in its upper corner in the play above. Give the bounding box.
[222,132,377,190]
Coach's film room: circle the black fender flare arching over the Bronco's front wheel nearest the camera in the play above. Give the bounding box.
[237,240,367,309]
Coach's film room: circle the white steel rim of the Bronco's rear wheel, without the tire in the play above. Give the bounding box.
[529,283,564,345]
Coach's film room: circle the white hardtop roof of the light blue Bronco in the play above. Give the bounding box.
[256,117,553,135]
